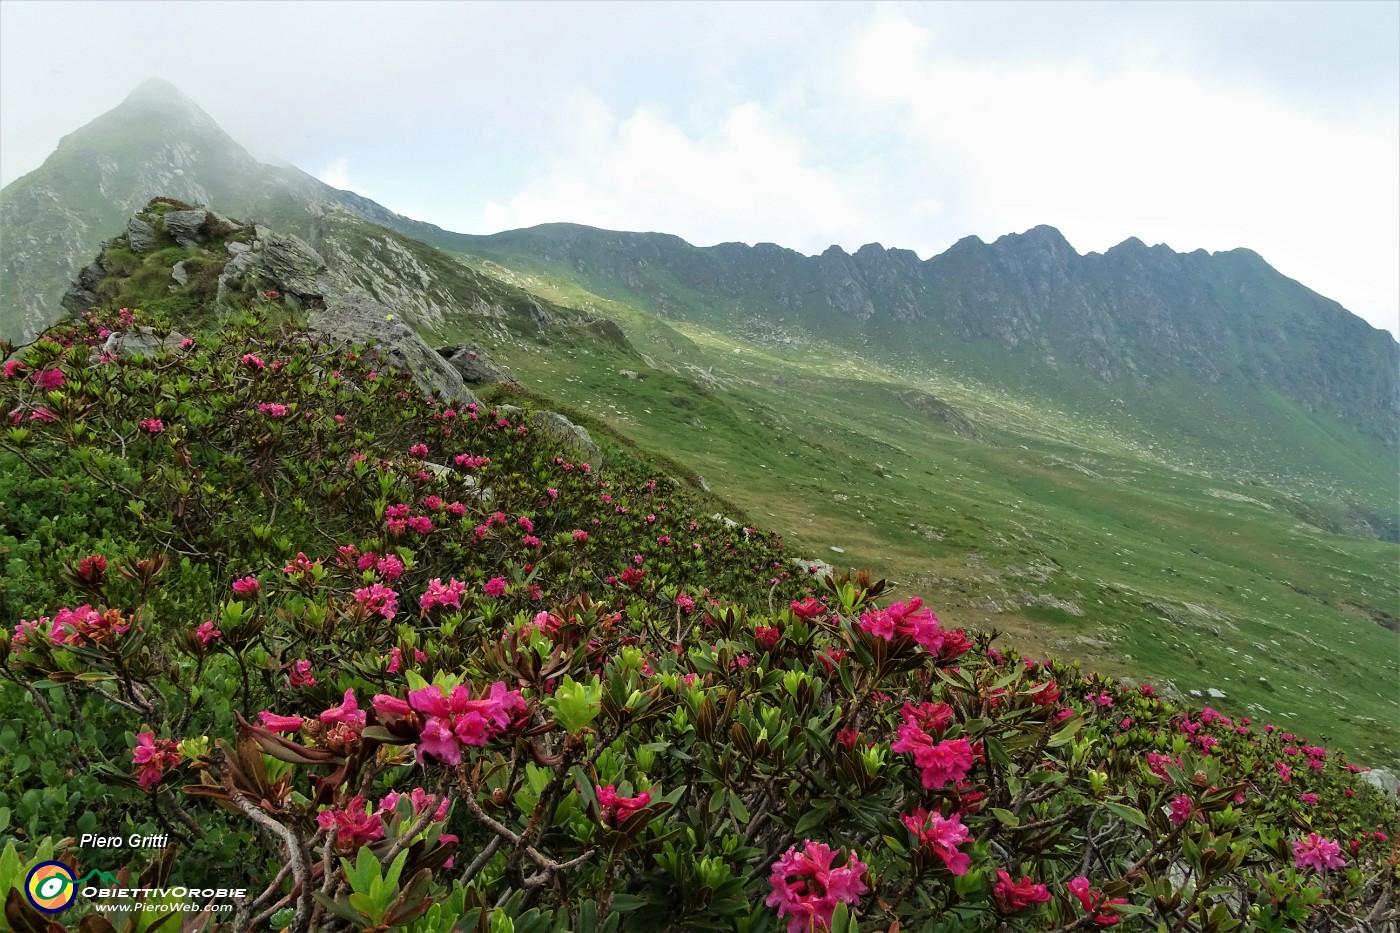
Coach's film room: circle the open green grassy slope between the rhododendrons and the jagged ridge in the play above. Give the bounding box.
[448,257,1400,763]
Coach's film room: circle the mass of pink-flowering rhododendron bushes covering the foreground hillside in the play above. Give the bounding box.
[0,308,1397,933]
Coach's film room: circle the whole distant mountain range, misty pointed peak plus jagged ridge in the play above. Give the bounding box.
[0,80,1400,448]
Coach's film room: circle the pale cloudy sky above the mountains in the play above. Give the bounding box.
[0,0,1400,332]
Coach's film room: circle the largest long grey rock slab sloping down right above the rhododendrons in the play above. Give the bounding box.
[308,287,480,405]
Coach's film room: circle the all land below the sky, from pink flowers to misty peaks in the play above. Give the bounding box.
[0,80,1400,933]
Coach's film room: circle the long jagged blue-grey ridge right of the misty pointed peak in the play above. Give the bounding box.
[454,224,1400,447]
